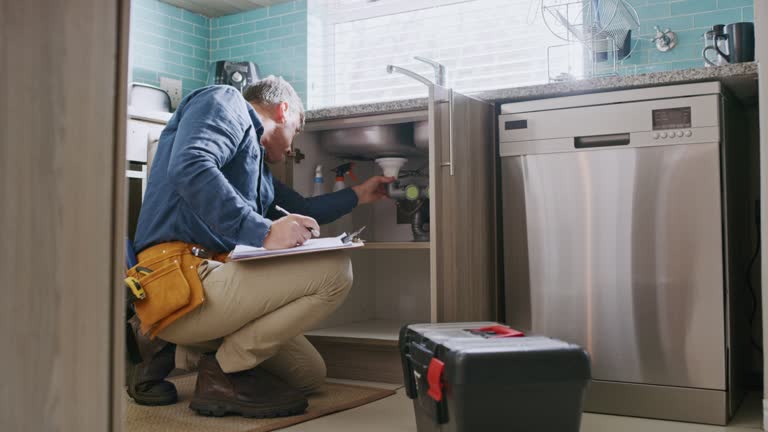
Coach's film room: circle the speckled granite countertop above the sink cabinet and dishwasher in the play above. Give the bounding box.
[306,63,757,121]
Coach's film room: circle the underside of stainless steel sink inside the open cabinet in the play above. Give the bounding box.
[320,123,426,160]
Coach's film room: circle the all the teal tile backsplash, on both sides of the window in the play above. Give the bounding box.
[130,0,754,103]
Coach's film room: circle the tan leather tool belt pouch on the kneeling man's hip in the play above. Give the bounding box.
[127,241,227,338]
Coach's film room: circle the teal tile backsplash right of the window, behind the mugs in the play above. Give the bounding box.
[619,0,754,75]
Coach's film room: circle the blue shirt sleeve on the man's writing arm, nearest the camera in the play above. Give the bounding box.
[168,89,272,247]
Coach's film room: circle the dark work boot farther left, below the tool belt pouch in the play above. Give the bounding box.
[128,344,179,405]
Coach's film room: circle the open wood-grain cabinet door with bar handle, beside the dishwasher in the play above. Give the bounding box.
[429,86,497,322]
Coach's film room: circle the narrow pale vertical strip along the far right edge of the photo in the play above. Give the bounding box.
[755,0,768,430]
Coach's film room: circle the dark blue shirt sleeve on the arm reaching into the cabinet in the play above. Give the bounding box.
[268,179,357,225]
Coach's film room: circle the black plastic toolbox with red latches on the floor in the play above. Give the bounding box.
[400,322,590,432]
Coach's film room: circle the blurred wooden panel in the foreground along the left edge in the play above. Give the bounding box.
[0,0,130,432]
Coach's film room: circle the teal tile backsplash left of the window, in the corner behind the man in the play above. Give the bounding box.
[130,0,307,101]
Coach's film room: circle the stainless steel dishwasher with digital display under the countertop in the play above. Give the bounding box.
[499,83,751,424]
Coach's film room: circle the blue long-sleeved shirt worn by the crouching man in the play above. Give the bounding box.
[135,85,357,252]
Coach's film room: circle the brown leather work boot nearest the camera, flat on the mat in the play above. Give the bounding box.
[189,355,309,418]
